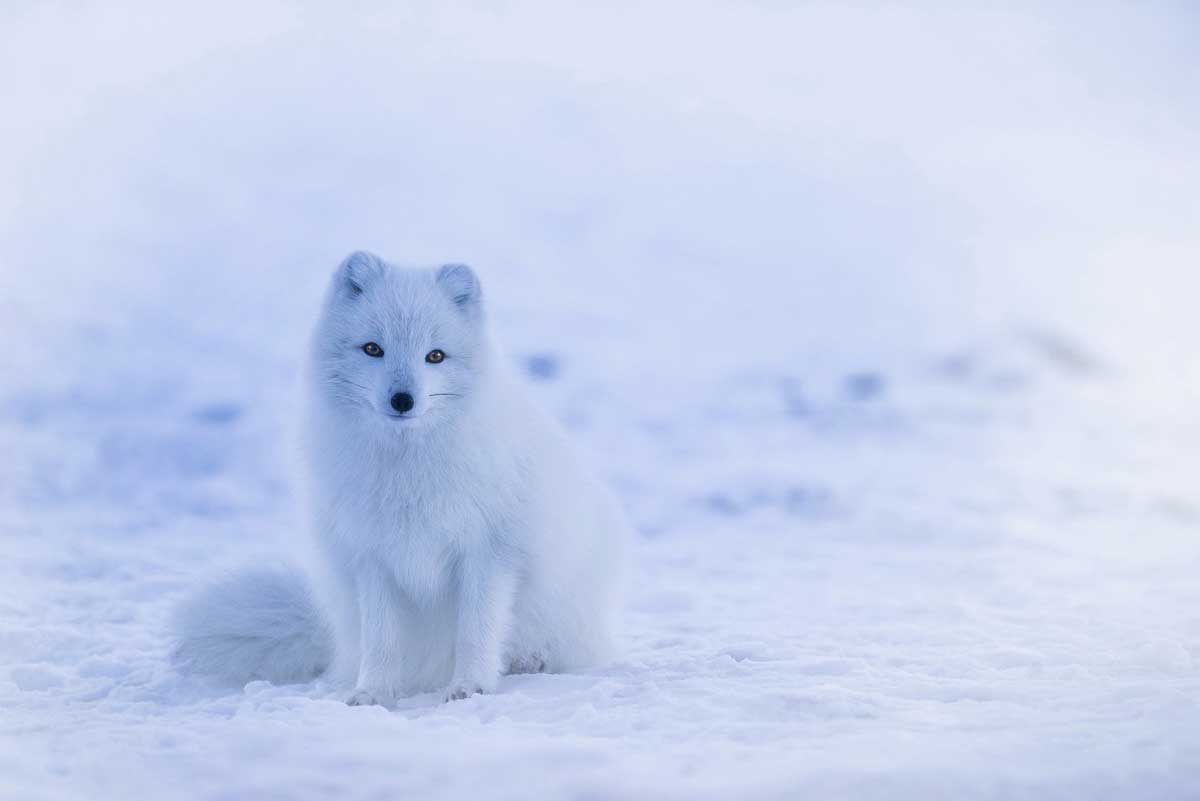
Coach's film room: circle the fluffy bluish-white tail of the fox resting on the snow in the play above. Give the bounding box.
[173,568,334,686]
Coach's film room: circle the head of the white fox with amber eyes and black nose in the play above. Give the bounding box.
[314,252,487,429]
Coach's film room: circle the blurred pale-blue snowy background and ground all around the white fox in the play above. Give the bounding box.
[0,0,1200,801]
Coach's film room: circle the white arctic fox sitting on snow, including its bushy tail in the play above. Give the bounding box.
[175,252,628,705]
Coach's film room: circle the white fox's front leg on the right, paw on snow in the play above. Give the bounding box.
[445,556,516,701]
